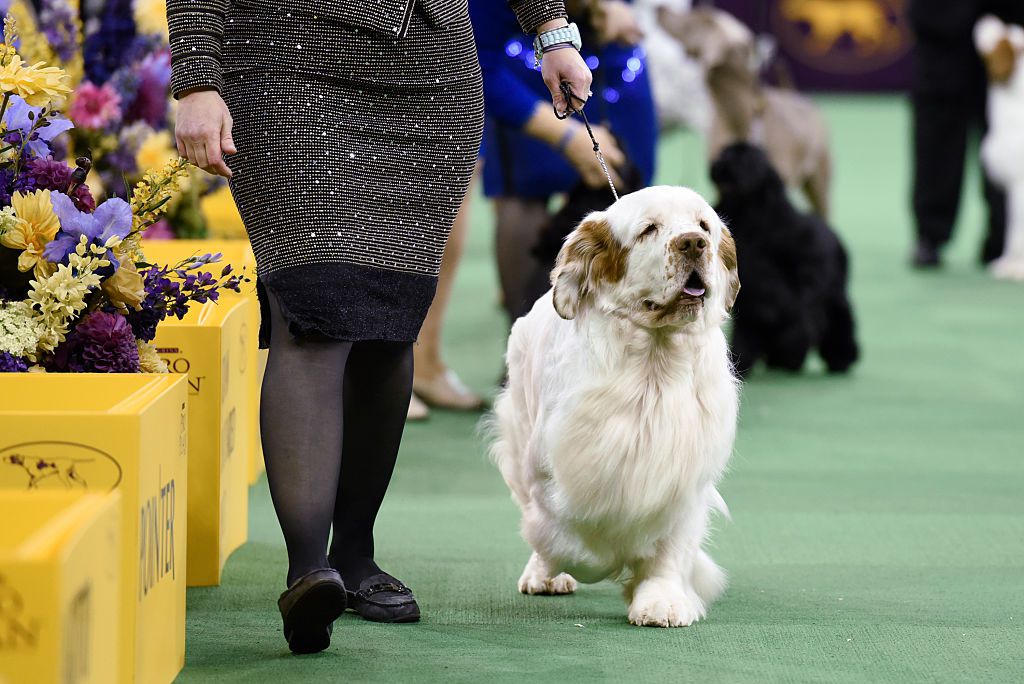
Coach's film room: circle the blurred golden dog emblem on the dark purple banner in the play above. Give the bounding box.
[773,0,910,74]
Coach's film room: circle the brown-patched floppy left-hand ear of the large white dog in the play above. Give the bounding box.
[551,212,626,320]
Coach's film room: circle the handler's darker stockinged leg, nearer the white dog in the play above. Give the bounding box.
[330,342,413,591]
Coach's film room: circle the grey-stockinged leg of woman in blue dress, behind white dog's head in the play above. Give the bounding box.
[495,198,551,323]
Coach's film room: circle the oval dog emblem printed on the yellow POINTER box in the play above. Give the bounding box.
[0,441,121,491]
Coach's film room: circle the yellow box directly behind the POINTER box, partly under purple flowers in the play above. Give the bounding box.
[153,298,252,587]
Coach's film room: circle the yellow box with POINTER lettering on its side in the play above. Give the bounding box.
[0,373,188,684]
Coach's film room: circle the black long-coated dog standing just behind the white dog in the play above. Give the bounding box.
[711,142,859,375]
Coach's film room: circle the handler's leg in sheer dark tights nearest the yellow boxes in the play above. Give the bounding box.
[260,292,352,586]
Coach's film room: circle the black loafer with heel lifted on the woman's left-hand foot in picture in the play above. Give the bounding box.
[278,567,348,653]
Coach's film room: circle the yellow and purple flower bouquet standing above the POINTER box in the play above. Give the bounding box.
[0,17,247,373]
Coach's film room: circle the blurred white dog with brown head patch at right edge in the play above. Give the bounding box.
[974,15,1024,281]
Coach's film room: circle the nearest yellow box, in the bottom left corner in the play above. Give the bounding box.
[0,490,121,684]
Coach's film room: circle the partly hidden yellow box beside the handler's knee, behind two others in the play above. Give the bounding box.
[142,240,266,484]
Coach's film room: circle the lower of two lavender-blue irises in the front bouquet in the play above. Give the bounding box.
[43,193,131,270]
